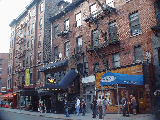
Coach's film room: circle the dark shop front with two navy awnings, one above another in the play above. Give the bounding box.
[38,60,80,113]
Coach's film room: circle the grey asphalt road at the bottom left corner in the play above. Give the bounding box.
[0,111,62,120]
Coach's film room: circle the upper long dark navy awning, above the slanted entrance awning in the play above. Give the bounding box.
[40,59,68,71]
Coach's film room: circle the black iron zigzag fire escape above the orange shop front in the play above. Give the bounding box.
[84,0,120,70]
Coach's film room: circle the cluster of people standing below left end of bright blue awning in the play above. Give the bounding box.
[92,96,107,119]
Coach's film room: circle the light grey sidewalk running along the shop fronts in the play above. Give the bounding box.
[0,108,158,120]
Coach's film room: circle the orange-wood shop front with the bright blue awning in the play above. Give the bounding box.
[95,64,152,113]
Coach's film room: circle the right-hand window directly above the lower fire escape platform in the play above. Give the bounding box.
[108,21,118,41]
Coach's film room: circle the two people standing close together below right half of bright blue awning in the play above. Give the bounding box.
[122,93,137,116]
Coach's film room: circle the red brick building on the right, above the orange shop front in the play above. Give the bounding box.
[46,0,156,113]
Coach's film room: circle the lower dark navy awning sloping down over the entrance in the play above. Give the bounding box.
[45,70,78,90]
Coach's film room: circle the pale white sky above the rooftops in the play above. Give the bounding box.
[0,0,71,53]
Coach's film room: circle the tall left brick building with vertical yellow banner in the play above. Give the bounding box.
[7,0,69,111]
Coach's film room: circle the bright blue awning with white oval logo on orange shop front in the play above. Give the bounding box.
[100,72,143,86]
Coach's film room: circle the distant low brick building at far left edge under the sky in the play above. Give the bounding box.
[0,53,9,95]
